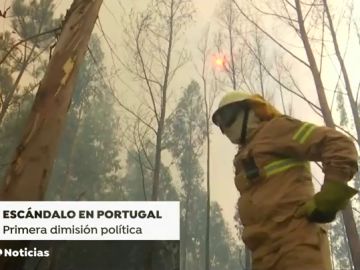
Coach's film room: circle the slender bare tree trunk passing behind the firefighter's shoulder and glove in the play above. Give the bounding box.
[295,0,360,270]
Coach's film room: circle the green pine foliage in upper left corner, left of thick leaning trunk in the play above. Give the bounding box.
[0,0,58,132]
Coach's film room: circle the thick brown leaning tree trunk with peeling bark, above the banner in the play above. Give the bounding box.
[0,0,102,270]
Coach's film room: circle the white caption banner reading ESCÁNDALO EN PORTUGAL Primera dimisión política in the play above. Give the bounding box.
[0,201,180,240]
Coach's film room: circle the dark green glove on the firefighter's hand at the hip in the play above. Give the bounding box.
[295,180,357,223]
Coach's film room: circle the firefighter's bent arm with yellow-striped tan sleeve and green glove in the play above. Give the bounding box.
[273,118,358,222]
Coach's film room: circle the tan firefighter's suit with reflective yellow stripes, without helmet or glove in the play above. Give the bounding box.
[234,116,357,270]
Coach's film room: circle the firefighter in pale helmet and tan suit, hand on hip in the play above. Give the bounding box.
[212,91,358,270]
